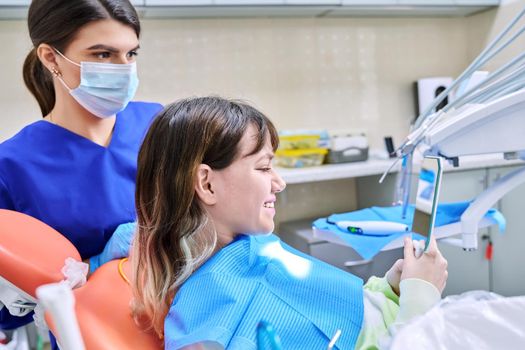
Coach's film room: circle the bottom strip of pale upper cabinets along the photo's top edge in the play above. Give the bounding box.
[0,0,500,19]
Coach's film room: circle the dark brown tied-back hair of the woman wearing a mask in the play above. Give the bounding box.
[23,0,140,116]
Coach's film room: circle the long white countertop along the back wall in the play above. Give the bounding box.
[277,154,525,184]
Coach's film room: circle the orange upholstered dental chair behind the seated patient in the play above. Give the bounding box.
[0,210,162,350]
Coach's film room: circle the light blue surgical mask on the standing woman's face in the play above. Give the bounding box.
[55,49,139,118]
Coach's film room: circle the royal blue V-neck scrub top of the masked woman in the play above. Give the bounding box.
[0,102,162,329]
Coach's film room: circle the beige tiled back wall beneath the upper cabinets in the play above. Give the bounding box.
[0,18,467,146]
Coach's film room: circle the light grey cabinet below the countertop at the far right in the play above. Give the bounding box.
[439,166,525,296]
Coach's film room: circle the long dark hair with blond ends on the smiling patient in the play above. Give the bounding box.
[131,97,279,336]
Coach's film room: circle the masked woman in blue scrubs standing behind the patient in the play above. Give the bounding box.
[0,0,162,340]
